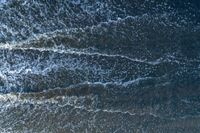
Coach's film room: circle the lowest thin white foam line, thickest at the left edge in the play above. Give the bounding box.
[0,94,164,118]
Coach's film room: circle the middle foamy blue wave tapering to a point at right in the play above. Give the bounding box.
[0,40,189,92]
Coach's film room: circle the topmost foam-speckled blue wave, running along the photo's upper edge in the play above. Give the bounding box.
[0,0,198,42]
